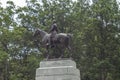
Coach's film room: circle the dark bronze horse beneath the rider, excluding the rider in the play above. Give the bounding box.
[34,29,72,56]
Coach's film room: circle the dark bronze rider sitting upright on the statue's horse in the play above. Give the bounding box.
[49,20,58,47]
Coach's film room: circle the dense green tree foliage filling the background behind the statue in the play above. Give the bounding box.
[0,0,120,80]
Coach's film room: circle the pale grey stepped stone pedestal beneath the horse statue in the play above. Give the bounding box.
[36,59,80,80]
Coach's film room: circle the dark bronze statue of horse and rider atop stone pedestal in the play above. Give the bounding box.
[34,21,72,58]
